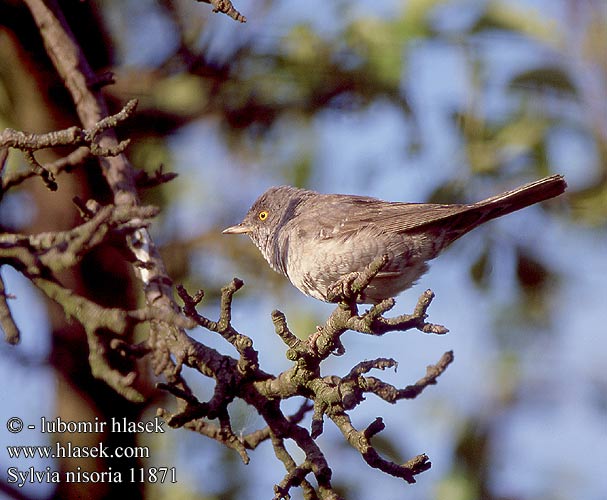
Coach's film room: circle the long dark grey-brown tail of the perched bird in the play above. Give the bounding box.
[448,175,567,241]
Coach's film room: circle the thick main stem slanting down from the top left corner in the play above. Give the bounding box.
[25,0,180,377]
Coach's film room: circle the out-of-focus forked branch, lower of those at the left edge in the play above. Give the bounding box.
[0,195,189,401]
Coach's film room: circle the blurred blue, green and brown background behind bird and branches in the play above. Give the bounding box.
[0,0,607,500]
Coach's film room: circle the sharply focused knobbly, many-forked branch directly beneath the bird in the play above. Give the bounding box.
[167,264,453,498]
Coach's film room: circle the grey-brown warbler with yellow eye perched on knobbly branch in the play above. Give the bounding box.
[223,175,567,304]
